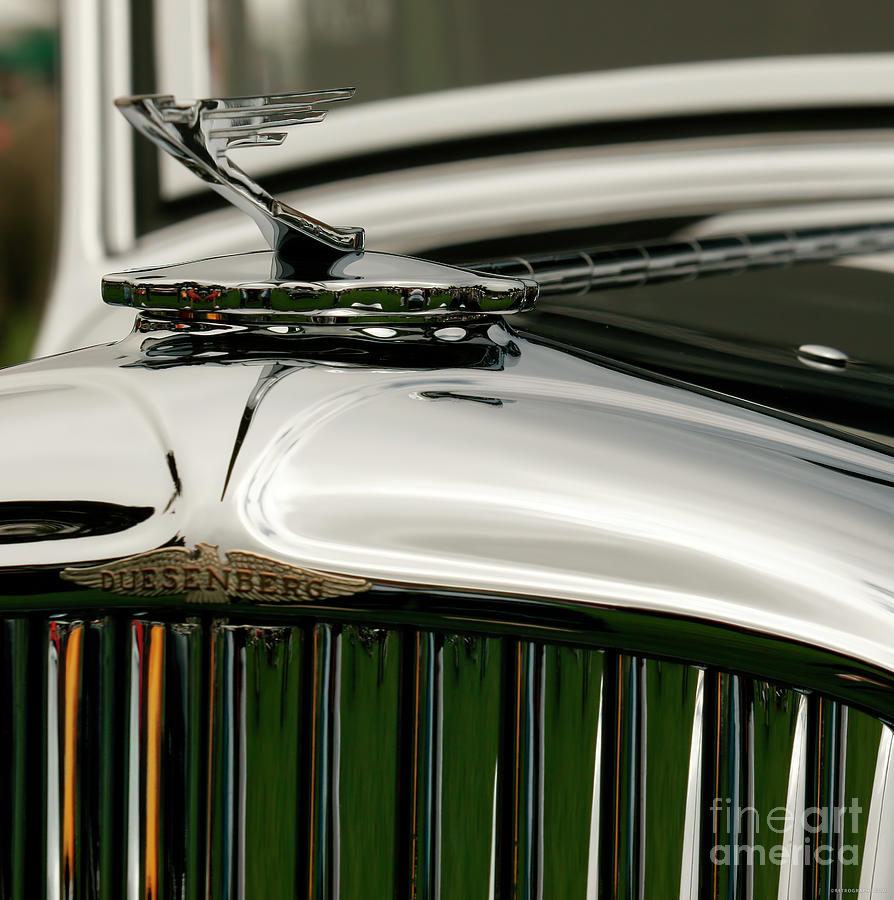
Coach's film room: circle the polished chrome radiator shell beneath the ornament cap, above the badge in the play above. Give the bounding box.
[0,319,894,669]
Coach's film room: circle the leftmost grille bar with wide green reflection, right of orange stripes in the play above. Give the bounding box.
[209,621,305,900]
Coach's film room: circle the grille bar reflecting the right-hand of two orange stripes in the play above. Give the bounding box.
[126,617,203,900]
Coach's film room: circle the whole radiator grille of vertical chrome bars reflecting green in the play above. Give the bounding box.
[0,614,891,900]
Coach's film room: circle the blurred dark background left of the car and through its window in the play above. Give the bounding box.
[0,0,894,365]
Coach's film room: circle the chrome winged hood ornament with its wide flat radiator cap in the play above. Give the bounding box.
[102,88,538,324]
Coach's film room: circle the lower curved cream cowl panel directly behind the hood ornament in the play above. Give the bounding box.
[45,130,894,354]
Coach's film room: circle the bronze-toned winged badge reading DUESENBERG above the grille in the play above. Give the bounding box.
[60,543,371,603]
